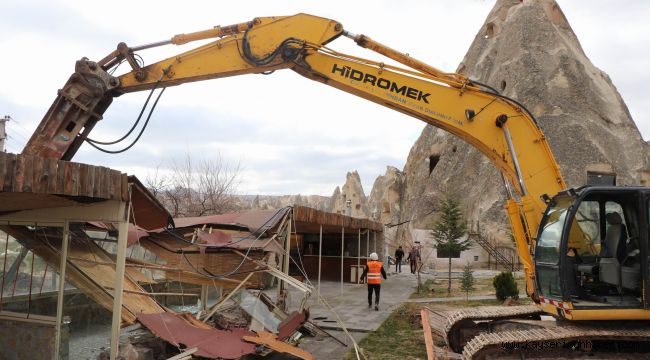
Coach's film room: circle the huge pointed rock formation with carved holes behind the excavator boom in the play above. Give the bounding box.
[392,0,650,243]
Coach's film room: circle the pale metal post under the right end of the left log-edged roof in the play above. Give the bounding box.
[111,202,131,360]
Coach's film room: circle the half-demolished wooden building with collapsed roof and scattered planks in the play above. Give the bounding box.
[0,154,383,359]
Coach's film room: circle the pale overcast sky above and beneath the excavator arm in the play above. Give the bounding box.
[0,0,650,196]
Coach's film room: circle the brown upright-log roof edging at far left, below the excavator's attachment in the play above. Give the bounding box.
[0,152,128,201]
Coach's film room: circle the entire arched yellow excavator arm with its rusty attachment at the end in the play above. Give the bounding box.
[23,14,566,295]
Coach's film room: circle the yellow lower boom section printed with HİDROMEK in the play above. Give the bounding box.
[293,52,564,208]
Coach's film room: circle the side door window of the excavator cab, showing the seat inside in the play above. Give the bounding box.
[563,191,641,308]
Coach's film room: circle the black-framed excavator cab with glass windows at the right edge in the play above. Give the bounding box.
[535,186,650,310]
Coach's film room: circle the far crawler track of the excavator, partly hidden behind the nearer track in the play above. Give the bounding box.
[429,305,544,353]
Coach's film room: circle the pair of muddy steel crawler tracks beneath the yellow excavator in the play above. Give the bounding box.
[422,305,650,359]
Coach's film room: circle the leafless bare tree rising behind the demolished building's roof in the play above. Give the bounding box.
[146,154,241,217]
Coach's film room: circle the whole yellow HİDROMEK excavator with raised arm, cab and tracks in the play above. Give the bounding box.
[23,14,650,358]
